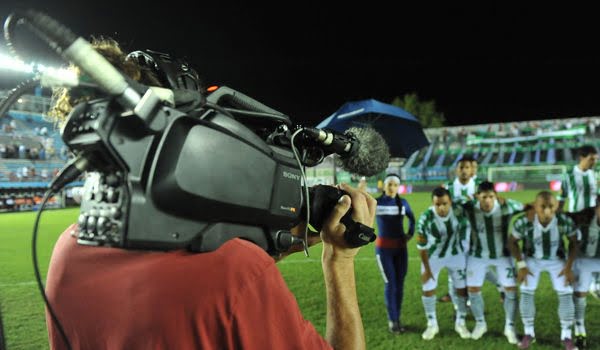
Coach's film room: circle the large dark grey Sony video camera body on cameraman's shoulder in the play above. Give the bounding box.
[62,89,303,255]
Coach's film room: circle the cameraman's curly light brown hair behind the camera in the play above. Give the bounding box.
[47,37,162,127]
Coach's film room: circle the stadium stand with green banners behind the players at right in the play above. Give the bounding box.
[401,117,600,183]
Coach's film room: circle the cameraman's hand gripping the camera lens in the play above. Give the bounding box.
[321,184,377,259]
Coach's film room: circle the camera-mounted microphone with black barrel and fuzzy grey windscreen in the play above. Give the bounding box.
[303,127,390,176]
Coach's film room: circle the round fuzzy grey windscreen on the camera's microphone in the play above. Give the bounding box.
[341,127,390,176]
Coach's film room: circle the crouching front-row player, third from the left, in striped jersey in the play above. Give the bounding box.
[508,191,577,350]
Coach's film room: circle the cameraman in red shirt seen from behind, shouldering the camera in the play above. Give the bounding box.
[46,40,376,350]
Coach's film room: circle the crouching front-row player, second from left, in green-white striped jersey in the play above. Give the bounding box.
[463,181,524,344]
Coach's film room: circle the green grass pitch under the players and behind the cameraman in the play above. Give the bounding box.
[0,191,600,350]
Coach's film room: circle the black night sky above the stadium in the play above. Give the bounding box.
[0,0,600,125]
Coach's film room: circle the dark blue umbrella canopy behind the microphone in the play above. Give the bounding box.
[317,99,429,158]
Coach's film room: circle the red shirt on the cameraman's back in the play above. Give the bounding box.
[46,225,331,350]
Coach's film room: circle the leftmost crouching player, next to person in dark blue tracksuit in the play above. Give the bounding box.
[417,187,471,340]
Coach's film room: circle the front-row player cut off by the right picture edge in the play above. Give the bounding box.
[569,197,600,349]
